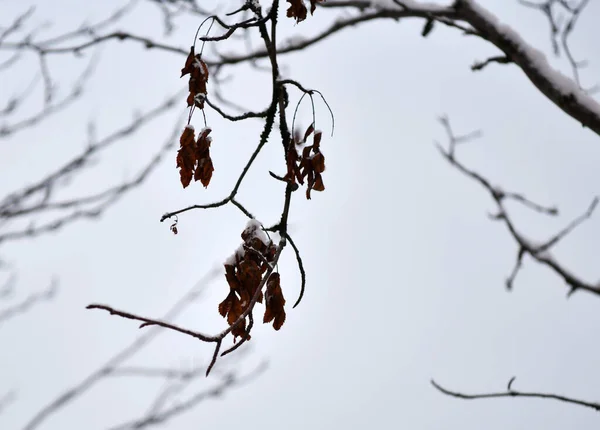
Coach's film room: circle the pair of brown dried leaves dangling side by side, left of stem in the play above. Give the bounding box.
[177,125,214,188]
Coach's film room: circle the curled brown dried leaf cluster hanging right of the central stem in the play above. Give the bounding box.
[284,124,325,199]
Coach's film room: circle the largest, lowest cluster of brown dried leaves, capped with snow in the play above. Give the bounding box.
[219,220,285,340]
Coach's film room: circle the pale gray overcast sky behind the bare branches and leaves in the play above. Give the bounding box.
[0,0,600,430]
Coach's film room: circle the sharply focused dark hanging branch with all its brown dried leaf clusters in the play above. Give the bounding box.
[88,0,334,375]
